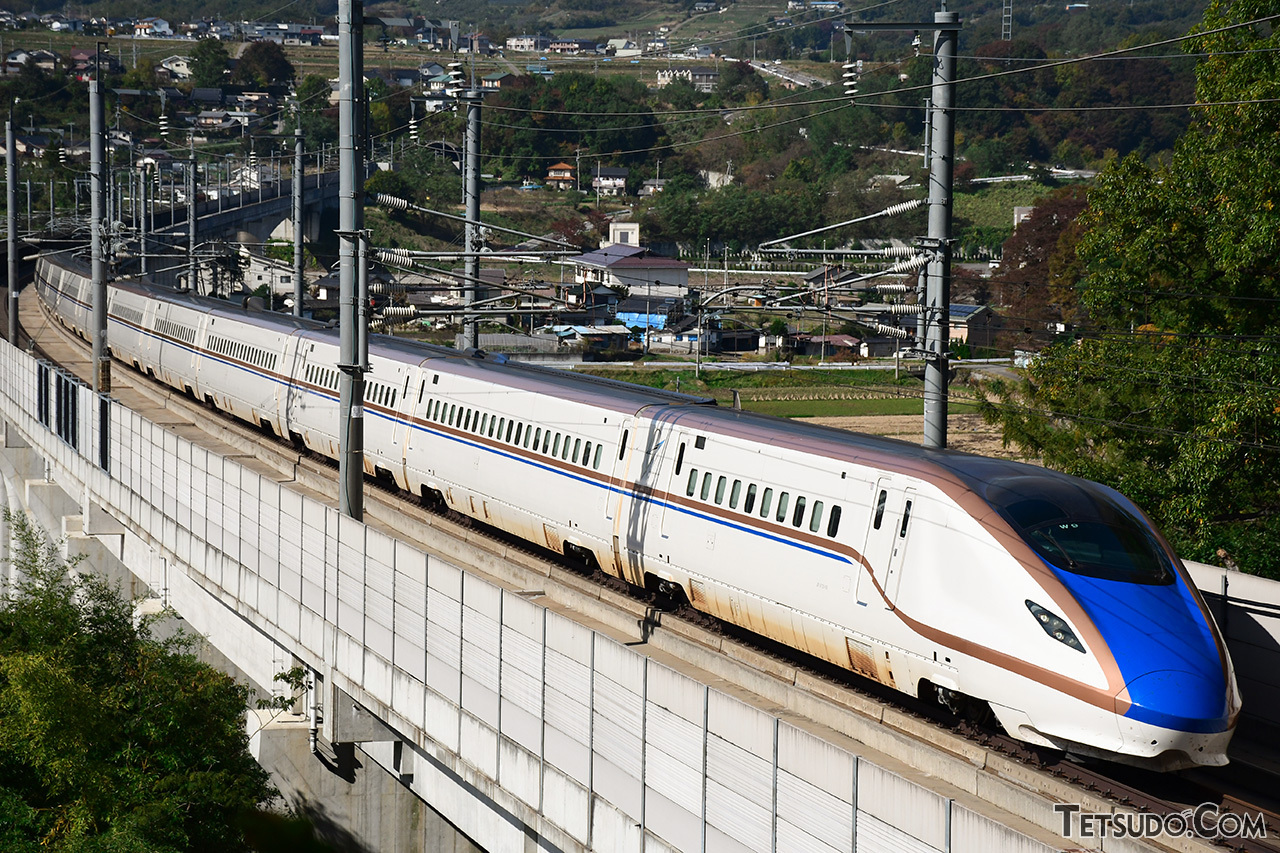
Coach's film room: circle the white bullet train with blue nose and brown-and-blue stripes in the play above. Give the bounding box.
[36,255,1240,770]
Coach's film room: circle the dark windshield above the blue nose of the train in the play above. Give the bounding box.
[1000,483,1174,585]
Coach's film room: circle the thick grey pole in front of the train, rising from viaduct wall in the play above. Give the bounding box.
[338,0,369,521]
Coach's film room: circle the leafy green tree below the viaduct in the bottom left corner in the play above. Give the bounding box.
[0,514,276,853]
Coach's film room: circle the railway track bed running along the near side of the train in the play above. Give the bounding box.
[22,289,1280,853]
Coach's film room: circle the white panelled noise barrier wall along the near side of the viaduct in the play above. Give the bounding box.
[0,333,1141,853]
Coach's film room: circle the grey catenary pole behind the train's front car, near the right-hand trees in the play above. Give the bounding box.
[924,4,960,447]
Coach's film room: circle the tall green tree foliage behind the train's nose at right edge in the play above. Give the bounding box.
[988,0,1280,576]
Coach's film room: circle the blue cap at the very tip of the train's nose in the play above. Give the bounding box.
[1116,670,1229,734]
